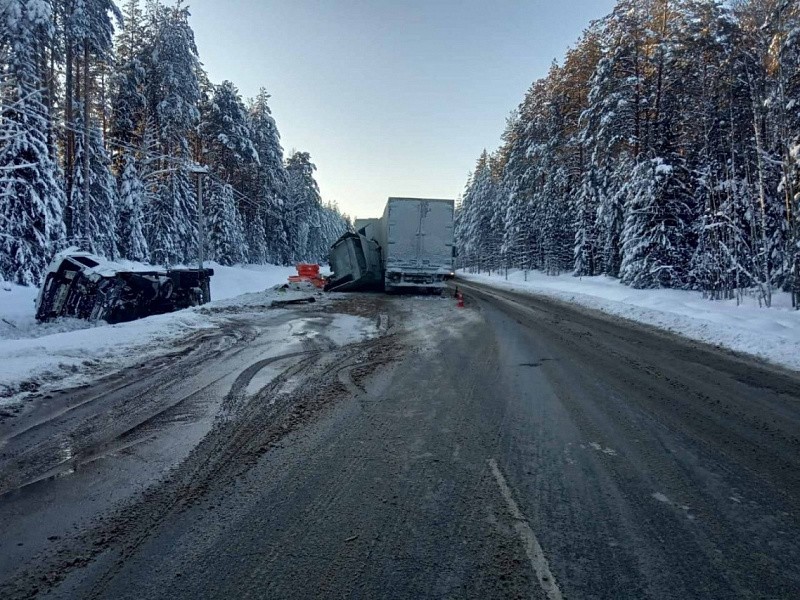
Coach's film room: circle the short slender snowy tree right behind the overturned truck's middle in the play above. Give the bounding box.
[117,151,150,261]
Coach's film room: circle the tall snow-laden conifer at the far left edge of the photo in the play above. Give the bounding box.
[0,0,65,285]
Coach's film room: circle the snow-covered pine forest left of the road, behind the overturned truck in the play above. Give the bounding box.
[0,0,349,285]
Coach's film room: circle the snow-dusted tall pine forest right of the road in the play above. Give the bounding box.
[456,0,800,306]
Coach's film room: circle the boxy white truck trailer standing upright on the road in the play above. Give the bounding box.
[376,198,454,293]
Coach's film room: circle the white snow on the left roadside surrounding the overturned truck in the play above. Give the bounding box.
[0,262,310,407]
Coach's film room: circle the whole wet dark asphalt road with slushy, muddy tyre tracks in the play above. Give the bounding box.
[0,282,800,599]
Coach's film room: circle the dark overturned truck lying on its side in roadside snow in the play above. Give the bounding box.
[36,249,214,323]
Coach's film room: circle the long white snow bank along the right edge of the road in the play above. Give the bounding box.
[459,271,800,370]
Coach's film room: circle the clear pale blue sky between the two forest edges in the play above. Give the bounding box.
[189,0,614,217]
